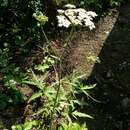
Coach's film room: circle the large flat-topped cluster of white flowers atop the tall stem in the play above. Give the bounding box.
[57,4,97,30]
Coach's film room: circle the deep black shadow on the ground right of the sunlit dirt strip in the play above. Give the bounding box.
[87,2,130,130]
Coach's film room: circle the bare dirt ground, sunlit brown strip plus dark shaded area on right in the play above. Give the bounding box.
[65,2,130,130]
